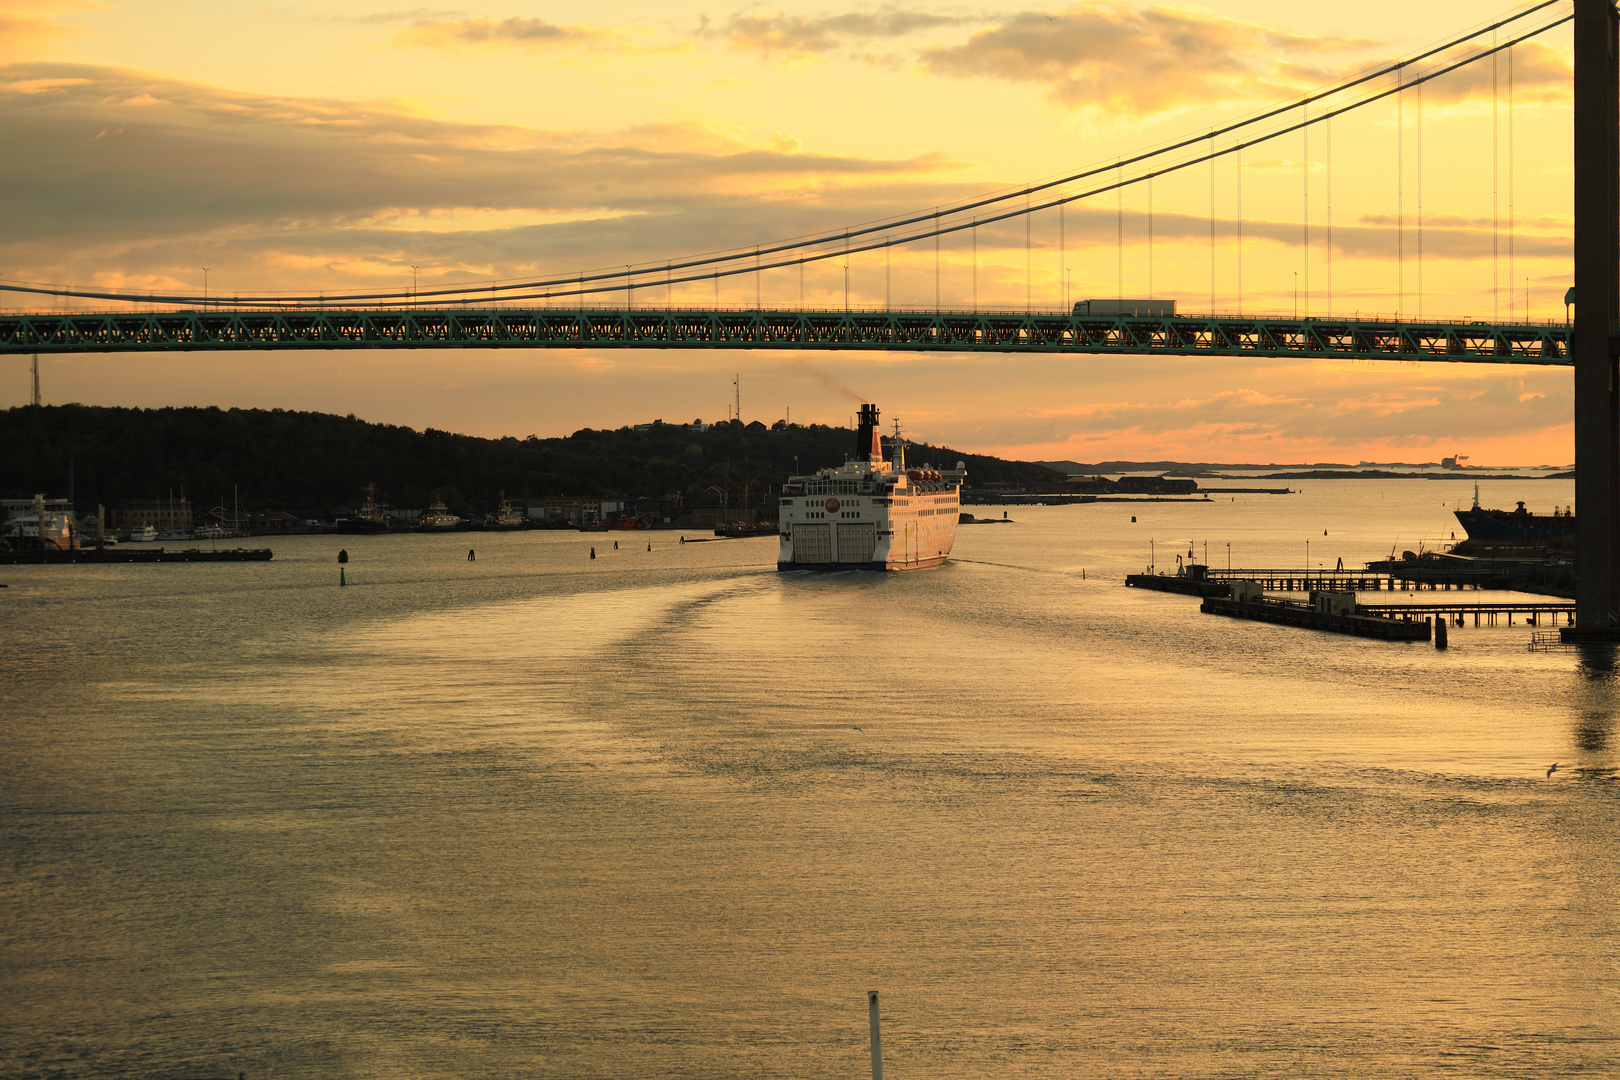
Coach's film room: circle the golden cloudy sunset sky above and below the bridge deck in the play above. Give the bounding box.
[0,0,1573,465]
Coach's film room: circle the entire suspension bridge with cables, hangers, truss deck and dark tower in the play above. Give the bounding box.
[0,0,1620,640]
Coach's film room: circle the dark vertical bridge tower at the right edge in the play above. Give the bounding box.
[1570,0,1620,638]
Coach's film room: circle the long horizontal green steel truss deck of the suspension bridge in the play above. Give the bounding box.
[0,308,1570,364]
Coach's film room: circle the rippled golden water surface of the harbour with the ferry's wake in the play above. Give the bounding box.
[0,481,1620,1080]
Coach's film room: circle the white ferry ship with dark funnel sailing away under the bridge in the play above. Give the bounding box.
[776,405,967,570]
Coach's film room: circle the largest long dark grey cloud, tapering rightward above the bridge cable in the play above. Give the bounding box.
[0,65,956,296]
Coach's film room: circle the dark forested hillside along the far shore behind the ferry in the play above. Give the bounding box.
[0,405,1061,515]
